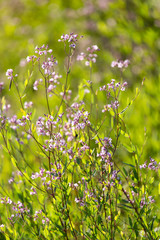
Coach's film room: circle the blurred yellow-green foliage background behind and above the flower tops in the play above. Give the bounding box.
[0,0,160,176]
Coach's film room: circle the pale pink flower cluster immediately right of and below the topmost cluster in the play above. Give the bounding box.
[77,45,99,66]
